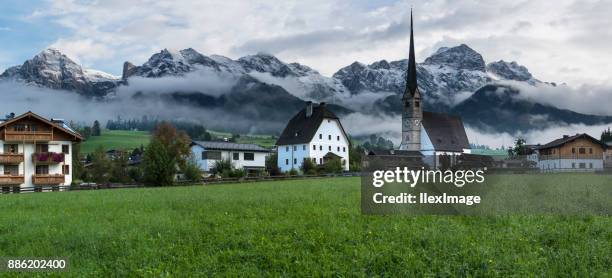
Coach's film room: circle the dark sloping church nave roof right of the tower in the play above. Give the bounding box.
[423,111,470,152]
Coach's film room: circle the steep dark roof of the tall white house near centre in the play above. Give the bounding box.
[276,104,350,146]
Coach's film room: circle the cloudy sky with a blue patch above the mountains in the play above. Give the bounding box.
[0,0,612,86]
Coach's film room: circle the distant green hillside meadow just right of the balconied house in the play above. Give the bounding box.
[81,130,151,154]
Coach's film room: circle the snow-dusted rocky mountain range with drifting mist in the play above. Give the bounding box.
[0,44,612,133]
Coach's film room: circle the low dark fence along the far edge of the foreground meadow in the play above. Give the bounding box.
[0,172,361,194]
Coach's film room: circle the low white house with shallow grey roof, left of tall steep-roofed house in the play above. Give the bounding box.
[191,141,270,175]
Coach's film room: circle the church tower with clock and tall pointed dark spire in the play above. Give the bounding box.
[399,10,423,151]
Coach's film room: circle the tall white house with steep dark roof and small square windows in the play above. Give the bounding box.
[276,102,350,172]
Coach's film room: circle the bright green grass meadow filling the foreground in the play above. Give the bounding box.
[0,178,612,277]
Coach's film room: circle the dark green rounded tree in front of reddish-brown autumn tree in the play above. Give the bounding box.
[142,137,176,186]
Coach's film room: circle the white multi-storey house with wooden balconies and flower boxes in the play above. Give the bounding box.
[0,112,83,192]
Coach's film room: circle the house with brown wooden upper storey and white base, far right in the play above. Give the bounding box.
[538,133,606,172]
